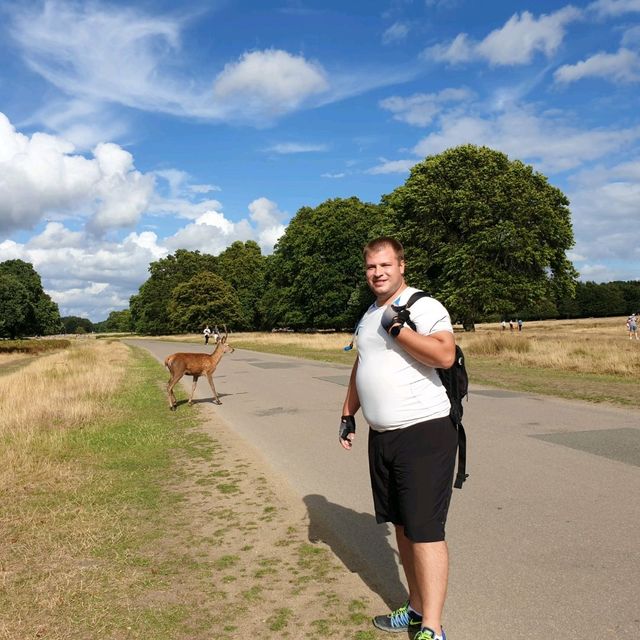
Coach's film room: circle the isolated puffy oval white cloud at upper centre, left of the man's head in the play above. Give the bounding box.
[213,49,329,120]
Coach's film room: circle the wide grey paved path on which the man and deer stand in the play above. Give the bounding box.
[128,340,640,640]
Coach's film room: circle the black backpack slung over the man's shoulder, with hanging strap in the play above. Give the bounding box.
[394,291,469,489]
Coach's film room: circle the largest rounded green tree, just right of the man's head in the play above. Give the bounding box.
[383,145,577,328]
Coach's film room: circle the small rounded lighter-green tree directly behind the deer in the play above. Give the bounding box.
[169,271,247,333]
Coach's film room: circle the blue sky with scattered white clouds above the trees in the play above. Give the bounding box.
[0,0,640,321]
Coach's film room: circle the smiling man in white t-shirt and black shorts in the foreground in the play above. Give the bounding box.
[340,237,458,640]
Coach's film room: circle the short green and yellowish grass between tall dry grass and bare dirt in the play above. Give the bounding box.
[0,350,218,639]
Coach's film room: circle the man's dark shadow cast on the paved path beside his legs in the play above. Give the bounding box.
[303,495,407,613]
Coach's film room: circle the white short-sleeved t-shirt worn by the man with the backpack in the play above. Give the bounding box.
[356,287,453,431]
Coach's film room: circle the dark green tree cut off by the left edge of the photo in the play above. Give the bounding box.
[0,260,62,338]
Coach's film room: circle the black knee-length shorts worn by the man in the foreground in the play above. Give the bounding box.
[369,416,458,542]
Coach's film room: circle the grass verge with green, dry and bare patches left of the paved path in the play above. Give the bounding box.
[0,343,378,640]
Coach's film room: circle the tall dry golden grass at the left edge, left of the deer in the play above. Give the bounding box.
[0,340,129,496]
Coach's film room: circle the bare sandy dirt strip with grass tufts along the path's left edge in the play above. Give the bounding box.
[158,408,385,640]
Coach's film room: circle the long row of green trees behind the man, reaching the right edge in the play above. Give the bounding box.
[6,145,640,335]
